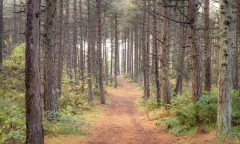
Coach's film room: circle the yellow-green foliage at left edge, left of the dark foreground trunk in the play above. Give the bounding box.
[0,44,26,143]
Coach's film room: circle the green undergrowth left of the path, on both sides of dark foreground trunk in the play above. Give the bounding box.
[0,44,104,144]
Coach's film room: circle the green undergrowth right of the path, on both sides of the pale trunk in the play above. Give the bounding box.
[156,91,240,137]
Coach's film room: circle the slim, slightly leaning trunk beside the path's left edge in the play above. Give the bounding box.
[96,0,105,104]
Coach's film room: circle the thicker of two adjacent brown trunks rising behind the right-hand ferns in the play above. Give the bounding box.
[188,0,202,101]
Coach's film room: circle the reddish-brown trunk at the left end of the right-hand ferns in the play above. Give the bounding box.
[160,1,171,108]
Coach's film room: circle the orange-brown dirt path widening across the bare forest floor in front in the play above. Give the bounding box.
[46,78,215,144]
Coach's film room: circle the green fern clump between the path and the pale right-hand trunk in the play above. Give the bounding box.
[159,92,217,135]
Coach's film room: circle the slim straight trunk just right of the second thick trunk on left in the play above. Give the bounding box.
[57,0,63,96]
